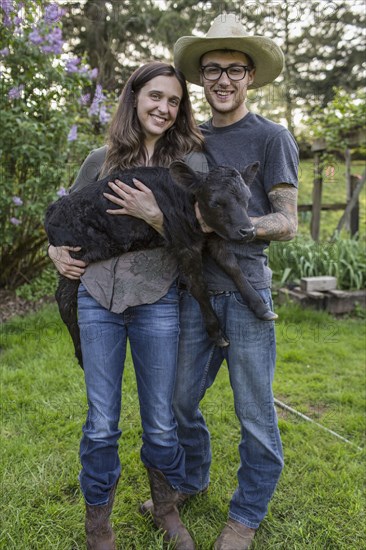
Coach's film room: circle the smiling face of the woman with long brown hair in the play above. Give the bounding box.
[136,76,183,141]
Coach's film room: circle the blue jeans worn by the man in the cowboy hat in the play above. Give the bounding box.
[173,290,283,529]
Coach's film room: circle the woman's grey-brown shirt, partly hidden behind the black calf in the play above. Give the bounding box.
[70,146,207,313]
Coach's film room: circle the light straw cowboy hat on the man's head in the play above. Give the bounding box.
[174,13,284,88]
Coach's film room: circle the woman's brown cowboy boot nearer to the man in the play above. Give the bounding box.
[147,468,195,550]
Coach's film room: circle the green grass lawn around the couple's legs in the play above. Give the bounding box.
[0,306,366,550]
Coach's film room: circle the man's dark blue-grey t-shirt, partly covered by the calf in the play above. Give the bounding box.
[200,113,299,291]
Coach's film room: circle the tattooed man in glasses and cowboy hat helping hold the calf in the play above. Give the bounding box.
[174,10,298,550]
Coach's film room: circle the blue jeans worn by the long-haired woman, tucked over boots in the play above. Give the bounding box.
[78,285,185,504]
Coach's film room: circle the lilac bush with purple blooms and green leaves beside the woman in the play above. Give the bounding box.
[0,0,109,288]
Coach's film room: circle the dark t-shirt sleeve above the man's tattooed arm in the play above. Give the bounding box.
[263,129,299,193]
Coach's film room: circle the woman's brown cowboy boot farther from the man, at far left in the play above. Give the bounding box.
[85,481,118,550]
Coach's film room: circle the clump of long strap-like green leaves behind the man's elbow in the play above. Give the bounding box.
[270,237,366,290]
